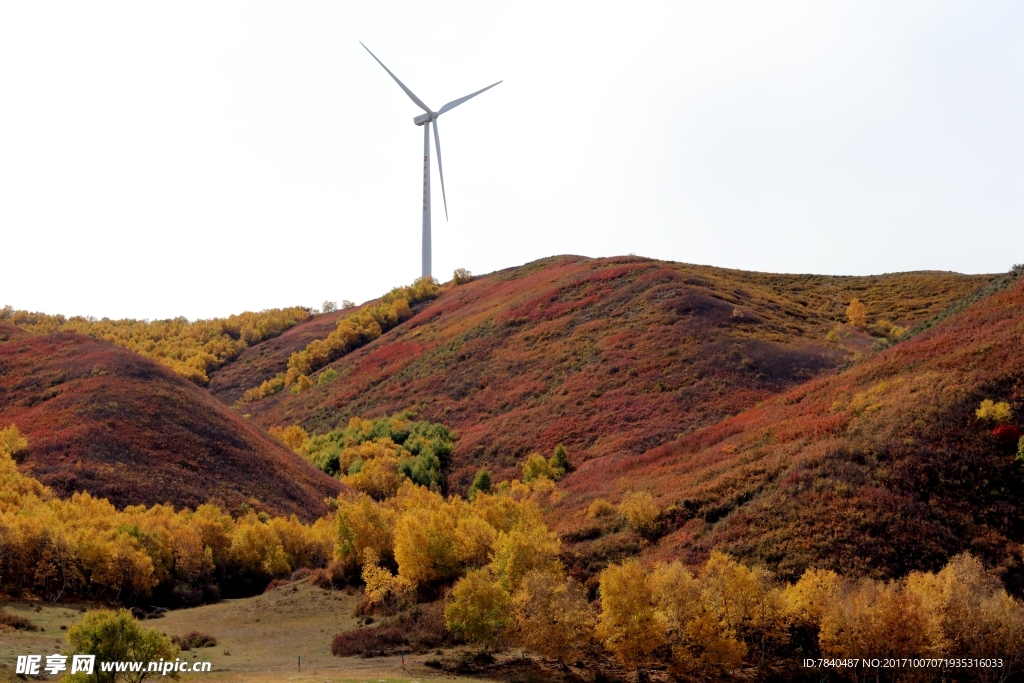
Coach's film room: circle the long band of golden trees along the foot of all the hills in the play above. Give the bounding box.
[0,419,1024,681]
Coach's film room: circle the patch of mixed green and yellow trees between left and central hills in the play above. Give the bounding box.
[270,412,458,500]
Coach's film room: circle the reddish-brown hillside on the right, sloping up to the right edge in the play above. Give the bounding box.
[552,270,1024,591]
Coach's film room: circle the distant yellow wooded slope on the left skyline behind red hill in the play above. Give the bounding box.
[0,306,310,386]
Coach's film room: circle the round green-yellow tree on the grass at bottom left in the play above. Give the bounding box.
[68,609,180,683]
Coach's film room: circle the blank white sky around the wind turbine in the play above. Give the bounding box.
[0,0,1024,318]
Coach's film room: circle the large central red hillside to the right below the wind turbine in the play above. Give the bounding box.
[228,256,990,489]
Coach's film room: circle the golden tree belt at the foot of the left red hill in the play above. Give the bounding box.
[0,440,334,599]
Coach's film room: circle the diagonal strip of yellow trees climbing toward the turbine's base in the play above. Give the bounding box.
[239,276,442,403]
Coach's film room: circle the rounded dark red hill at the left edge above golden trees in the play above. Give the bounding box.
[0,326,341,520]
